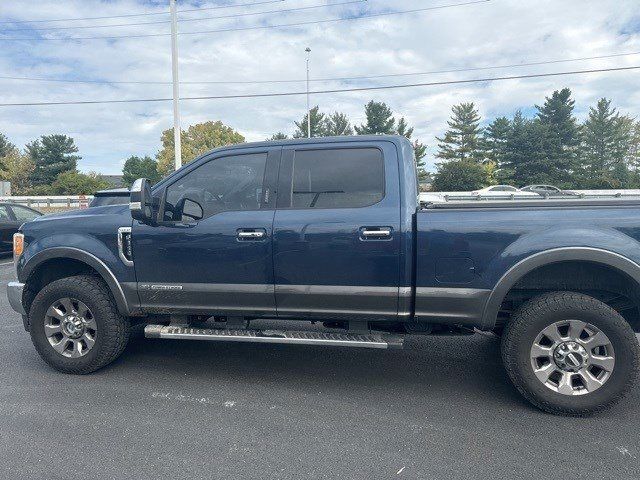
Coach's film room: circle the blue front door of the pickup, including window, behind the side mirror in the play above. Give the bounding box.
[132,147,281,316]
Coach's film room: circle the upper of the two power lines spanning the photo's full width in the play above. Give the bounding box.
[0,51,640,85]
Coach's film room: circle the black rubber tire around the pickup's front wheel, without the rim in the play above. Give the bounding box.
[29,275,130,375]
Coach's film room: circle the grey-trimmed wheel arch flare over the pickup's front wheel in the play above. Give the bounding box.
[19,247,132,316]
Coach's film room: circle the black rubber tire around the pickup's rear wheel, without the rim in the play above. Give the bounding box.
[502,292,640,416]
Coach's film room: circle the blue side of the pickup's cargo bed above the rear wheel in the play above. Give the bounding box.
[415,197,640,329]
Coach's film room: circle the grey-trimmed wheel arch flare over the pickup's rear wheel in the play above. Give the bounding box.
[482,247,640,330]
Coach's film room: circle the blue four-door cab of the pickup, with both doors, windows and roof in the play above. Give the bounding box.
[131,138,415,321]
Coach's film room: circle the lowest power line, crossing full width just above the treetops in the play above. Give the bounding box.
[0,65,640,107]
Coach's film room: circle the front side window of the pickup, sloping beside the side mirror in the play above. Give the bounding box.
[164,153,267,221]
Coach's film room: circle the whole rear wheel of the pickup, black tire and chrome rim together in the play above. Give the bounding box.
[502,292,640,416]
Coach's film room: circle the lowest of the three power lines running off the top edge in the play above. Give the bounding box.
[0,0,492,41]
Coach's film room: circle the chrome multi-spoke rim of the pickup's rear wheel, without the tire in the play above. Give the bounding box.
[530,320,615,395]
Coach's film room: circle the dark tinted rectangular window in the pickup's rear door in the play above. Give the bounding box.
[291,148,384,208]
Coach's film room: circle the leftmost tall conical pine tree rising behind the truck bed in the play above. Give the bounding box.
[436,103,484,162]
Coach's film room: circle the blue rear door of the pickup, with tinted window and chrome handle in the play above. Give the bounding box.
[273,141,400,320]
